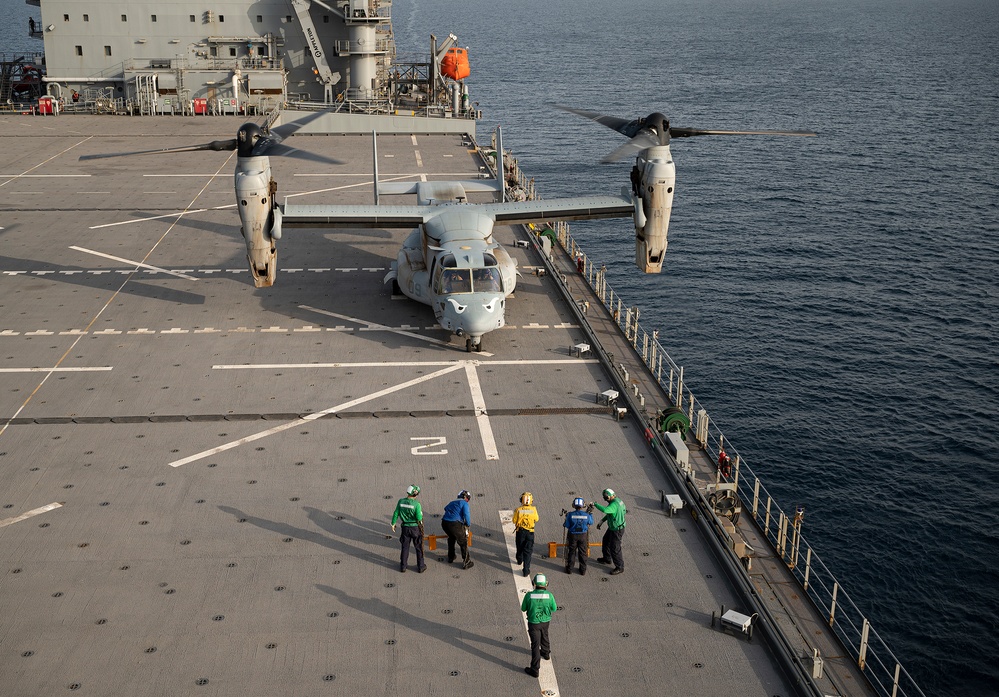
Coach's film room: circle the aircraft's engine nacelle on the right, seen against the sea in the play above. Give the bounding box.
[631,145,676,273]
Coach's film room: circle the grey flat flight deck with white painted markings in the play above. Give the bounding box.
[0,116,794,697]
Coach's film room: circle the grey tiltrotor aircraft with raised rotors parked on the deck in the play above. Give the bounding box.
[80,109,814,351]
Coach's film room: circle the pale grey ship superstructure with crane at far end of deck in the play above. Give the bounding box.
[23,0,473,117]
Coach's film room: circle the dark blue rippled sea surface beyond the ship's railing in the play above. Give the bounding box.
[0,0,999,696]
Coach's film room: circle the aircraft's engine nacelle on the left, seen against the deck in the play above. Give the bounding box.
[236,157,281,288]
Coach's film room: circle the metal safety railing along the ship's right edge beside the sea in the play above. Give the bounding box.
[507,150,925,697]
